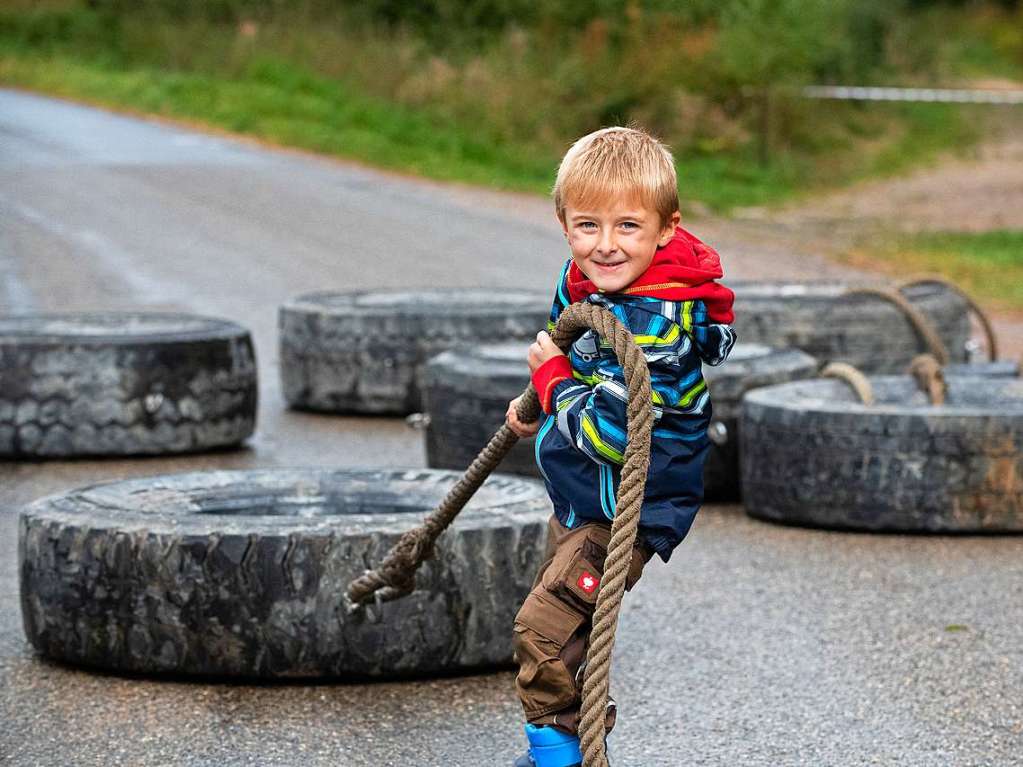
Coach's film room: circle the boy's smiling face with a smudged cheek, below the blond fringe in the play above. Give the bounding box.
[561,199,679,292]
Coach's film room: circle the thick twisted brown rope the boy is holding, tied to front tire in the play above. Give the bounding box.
[346,304,654,767]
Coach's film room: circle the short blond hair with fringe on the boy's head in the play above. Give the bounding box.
[553,128,678,225]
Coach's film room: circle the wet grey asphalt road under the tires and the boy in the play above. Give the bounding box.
[0,86,1023,767]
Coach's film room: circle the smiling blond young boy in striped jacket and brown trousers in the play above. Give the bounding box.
[507,128,736,767]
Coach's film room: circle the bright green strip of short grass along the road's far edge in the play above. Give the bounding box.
[0,49,805,211]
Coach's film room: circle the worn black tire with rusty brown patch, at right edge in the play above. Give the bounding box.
[741,376,1023,533]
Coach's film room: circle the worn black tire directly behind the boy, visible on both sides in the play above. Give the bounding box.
[424,344,817,500]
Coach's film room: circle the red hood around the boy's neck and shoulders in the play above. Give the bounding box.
[567,226,736,324]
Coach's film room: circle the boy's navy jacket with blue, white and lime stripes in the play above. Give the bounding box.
[533,228,736,561]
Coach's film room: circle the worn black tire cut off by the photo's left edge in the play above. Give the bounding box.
[0,313,257,458]
